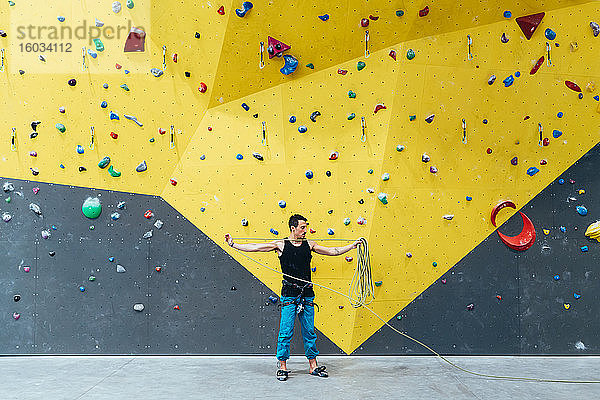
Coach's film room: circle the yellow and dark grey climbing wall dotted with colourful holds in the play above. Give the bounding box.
[0,0,600,354]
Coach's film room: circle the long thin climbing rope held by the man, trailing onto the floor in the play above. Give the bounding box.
[233,238,600,383]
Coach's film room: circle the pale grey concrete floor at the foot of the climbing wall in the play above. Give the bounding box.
[0,356,600,400]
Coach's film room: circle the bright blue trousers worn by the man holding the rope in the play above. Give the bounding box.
[277,296,319,361]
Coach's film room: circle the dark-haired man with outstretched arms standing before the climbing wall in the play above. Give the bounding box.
[225,214,360,381]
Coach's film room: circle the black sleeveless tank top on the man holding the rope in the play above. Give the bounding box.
[279,239,315,297]
